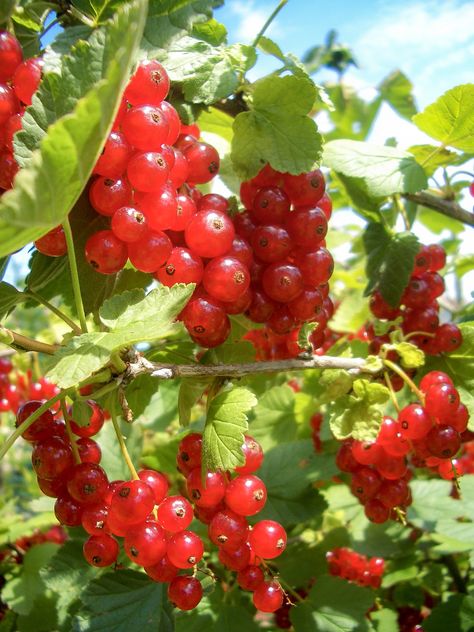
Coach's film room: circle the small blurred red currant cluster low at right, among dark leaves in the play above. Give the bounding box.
[326,547,385,588]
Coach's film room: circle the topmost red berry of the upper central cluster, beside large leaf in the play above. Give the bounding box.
[125,59,170,105]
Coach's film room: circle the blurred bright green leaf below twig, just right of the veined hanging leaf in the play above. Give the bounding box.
[250,385,297,451]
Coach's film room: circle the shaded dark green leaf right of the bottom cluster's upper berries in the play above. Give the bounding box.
[257,440,327,527]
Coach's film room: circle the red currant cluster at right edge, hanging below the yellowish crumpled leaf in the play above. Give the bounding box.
[336,371,472,523]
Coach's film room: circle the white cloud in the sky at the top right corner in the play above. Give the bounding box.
[354,0,474,106]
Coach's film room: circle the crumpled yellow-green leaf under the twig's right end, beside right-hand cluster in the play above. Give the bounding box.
[329,379,390,441]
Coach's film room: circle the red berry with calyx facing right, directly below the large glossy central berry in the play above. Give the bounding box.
[202,256,250,302]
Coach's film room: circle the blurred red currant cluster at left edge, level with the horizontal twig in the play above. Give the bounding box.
[0,356,59,414]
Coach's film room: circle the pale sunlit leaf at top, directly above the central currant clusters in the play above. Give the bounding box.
[161,35,256,104]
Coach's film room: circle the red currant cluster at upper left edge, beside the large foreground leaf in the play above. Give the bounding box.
[0,31,43,193]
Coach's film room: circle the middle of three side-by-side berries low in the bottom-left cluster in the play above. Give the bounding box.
[124,520,166,566]
